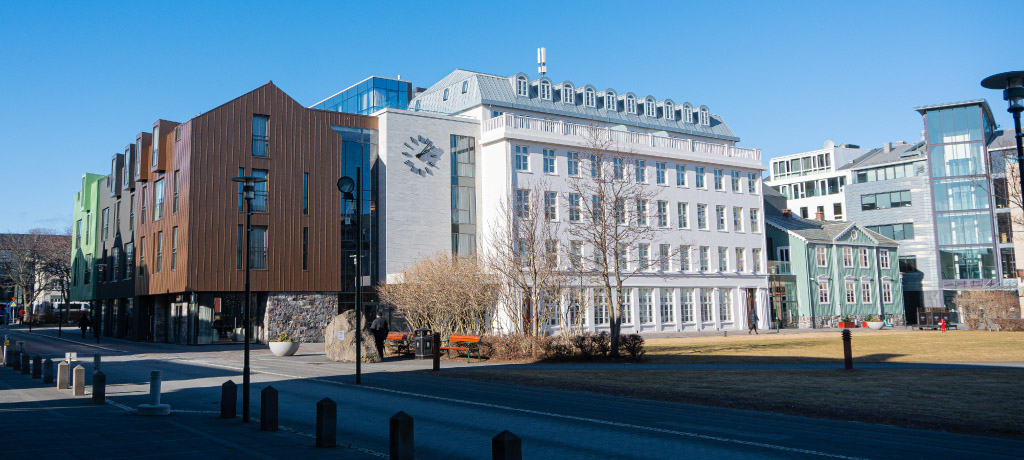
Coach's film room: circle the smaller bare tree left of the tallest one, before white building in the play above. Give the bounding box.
[487,181,567,335]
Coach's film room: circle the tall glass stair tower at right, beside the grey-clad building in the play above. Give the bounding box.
[915,99,1003,306]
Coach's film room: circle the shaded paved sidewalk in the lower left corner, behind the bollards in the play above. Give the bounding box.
[0,360,383,460]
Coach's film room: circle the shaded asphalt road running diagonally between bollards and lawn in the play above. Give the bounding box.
[0,323,1024,459]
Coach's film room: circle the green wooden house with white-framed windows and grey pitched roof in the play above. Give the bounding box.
[765,213,905,328]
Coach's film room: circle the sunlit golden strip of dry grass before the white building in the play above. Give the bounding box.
[646,330,1024,364]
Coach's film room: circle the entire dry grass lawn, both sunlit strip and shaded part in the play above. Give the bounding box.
[441,331,1024,438]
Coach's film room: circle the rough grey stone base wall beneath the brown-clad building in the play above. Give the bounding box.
[261,292,338,343]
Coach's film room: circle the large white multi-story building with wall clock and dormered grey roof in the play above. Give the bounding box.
[373,70,769,333]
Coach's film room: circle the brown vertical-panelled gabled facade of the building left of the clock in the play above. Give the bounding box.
[165,84,377,293]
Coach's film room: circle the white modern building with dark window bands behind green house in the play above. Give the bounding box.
[765,140,868,220]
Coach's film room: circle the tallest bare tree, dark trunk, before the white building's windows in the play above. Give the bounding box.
[565,129,678,356]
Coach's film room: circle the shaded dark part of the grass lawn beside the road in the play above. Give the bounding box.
[442,368,1024,438]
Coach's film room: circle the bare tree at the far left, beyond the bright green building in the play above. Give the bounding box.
[0,228,71,315]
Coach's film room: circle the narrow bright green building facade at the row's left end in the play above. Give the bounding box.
[71,173,106,302]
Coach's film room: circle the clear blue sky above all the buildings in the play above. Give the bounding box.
[0,0,1024,232]
